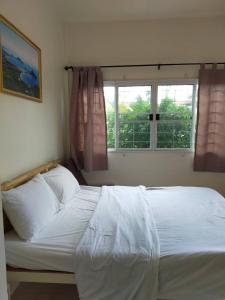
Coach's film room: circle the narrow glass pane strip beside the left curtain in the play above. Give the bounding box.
[104,86,115,148]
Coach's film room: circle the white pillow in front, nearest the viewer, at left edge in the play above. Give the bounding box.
[2,175,59,240]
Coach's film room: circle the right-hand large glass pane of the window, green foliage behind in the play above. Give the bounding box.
[157,84,194,149]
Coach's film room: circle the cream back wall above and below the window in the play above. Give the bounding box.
[66,18,225,195]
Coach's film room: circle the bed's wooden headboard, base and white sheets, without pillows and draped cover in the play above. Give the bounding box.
[2,162,225,300]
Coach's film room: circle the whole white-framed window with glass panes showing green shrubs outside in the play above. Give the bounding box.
[104,81,197,150]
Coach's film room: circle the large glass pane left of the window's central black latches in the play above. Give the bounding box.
[118,86,151,148]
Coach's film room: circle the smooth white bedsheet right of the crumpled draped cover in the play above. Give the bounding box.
[149,187,225,300]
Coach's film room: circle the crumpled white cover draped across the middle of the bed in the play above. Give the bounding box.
[74,186,160,300]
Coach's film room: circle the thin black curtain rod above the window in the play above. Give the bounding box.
[64,62,225,71]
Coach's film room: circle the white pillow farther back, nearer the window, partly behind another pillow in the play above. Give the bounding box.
[42,165,80,205]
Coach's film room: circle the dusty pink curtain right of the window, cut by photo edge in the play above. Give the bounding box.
[194,65,225,172]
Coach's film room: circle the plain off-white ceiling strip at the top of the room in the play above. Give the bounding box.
[50,0,225,22]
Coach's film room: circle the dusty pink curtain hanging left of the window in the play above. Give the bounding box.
[70,67,108,171]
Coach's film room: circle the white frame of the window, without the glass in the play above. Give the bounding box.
[104,79,198,152]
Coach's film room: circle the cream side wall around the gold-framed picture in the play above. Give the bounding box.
[0,0,64,181]
